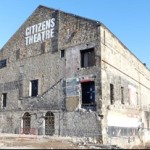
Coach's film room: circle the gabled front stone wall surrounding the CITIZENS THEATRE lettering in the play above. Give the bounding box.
[0,6,101,136]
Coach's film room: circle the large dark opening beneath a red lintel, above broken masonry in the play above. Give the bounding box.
[81,81,95,106]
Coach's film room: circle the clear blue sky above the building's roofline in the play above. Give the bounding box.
[0,0,150,68]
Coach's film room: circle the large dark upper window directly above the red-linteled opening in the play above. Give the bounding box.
[81,48,95,68]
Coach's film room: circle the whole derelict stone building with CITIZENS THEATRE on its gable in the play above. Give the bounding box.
[0,6,150,148]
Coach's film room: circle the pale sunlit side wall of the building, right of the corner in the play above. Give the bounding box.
[101,26,150,146]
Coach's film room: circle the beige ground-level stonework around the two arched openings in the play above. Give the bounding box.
[0,109,61,136]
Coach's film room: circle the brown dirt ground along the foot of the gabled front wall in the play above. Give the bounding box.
[0,133,104,149]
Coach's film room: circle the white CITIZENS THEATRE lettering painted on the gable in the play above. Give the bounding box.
[25,18,56,45]
